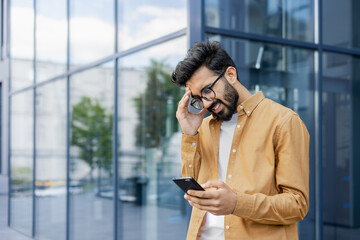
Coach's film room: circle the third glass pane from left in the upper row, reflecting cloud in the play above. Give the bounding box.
[70,0,115,67]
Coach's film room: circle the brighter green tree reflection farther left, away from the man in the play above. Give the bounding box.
[71,97,113,186]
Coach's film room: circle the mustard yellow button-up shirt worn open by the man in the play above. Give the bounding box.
[181,92,309,240]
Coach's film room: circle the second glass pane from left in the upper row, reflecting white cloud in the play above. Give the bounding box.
[36,0,67,82]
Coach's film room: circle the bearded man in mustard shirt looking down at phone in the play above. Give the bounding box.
[172,42,309,240]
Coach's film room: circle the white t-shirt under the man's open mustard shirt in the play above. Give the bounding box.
[200,113,238,240]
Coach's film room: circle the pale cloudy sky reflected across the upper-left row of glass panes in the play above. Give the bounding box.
[11,0,186,64]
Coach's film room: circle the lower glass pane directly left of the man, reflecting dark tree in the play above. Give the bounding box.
[118,37,189,240]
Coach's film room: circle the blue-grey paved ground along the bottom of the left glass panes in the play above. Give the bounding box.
[0,181,188,240]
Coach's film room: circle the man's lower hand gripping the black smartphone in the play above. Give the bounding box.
[184,181,237,215]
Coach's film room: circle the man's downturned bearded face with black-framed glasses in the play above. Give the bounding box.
[186,67,239,121]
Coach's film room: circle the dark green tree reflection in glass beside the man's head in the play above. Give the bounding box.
[134,60,182,148]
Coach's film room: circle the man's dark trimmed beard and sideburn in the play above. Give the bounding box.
[208,81,239,121]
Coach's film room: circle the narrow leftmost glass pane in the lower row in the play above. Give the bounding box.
[10,91,34,236]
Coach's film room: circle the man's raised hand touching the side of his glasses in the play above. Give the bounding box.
[176,87,207,136]
